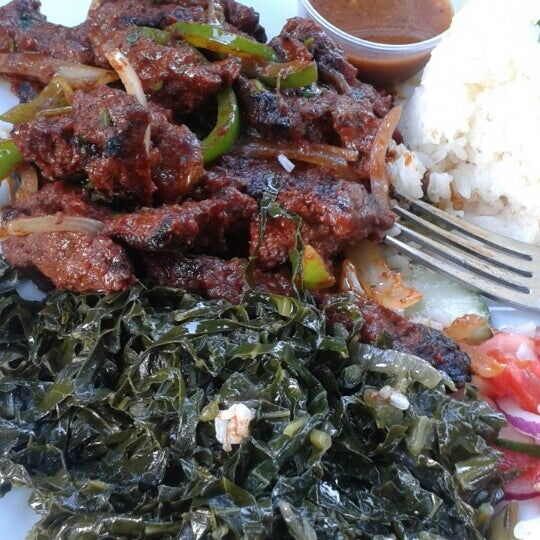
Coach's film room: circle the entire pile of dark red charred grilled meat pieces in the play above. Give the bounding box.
[0,0,470,386]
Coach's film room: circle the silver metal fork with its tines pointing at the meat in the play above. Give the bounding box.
[384,195,540,311]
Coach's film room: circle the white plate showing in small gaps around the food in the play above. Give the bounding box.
[0,0,540,540]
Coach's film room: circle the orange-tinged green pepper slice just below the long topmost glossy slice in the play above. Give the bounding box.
[242,59,319,89]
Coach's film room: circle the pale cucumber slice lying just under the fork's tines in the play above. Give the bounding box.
[403,264,491,326]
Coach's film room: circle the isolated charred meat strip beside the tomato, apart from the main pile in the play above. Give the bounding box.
[319,296,471,388]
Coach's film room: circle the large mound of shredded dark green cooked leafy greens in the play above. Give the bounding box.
[0,263,504,540]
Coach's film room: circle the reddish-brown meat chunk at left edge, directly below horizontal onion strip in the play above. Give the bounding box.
[2,232,134,293]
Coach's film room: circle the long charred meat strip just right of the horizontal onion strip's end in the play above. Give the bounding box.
[105,188,257,255]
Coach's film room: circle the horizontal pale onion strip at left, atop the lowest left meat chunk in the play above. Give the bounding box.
[5,216,105,236]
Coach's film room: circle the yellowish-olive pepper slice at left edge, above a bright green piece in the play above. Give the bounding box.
[0,76,73,124]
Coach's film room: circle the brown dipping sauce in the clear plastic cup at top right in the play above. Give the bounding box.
[310,0,454,87]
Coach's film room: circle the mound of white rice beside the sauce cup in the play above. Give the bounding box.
[389,0,540,243]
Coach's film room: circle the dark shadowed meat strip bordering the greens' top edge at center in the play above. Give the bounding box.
[143,255,292,304]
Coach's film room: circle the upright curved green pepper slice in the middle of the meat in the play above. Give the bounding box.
[202,88,240,163]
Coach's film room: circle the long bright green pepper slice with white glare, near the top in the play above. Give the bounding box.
[167,21,279,62]
